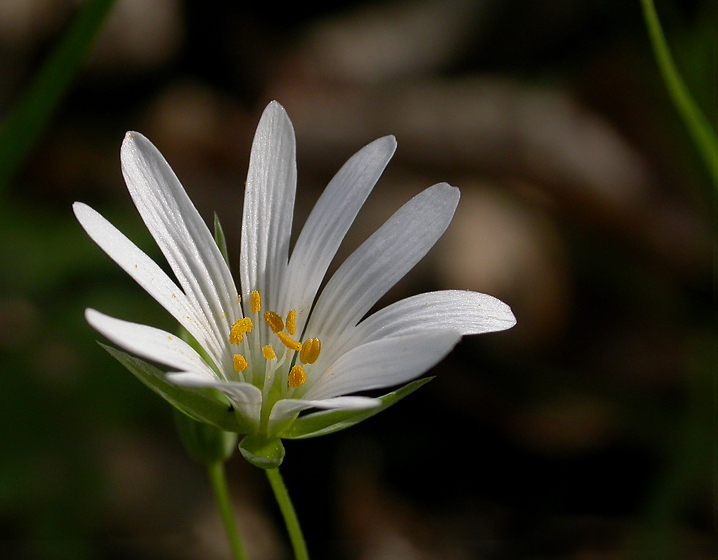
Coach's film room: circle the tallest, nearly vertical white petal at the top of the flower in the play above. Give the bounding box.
[240,101,297,314]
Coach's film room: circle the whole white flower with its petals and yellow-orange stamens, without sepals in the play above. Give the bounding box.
[74,102,515,456]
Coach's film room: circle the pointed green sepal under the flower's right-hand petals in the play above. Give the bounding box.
[279,377,434,439]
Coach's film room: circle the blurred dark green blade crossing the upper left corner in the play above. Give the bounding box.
[0,0,115,192]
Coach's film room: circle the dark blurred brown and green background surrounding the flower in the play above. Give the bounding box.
[0,0,718,560]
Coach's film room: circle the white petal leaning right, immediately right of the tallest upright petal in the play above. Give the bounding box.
[276,136,396,332]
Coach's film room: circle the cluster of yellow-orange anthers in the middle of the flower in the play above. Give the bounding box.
[229,290,322,389]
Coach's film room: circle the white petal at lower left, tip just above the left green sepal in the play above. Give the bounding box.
[85,309,214,377]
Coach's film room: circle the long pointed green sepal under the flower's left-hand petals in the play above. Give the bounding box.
[98,342,240,433]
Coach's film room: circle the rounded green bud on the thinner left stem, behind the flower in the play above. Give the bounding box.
[174,408,237,466]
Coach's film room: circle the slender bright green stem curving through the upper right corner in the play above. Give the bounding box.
[641,0,718,188]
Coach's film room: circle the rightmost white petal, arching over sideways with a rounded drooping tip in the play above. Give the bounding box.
[343,290,516,347]
